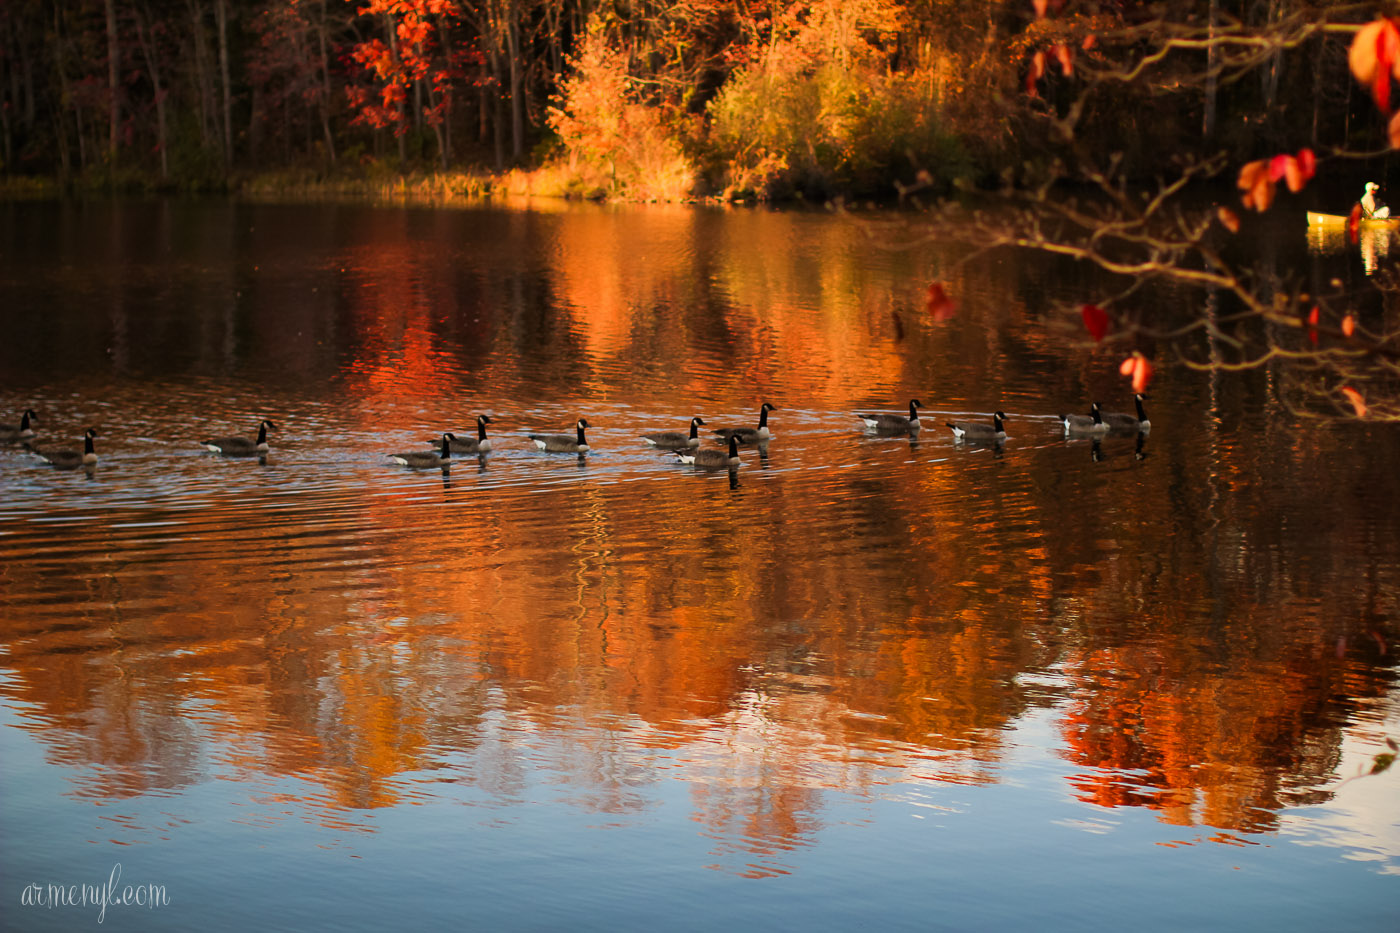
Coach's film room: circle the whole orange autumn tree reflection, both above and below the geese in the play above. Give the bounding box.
[0,210,1400,874]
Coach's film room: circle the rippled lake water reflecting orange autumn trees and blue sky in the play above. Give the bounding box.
[0,203,1400,930]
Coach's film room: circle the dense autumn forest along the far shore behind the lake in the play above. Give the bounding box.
[0,0,1387,198]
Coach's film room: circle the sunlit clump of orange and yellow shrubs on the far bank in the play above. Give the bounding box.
[511,0,973,200]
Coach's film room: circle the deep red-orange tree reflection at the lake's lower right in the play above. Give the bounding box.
[1063,633,1347,832]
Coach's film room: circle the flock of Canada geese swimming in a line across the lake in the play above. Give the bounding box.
[0,394,1152,469]
